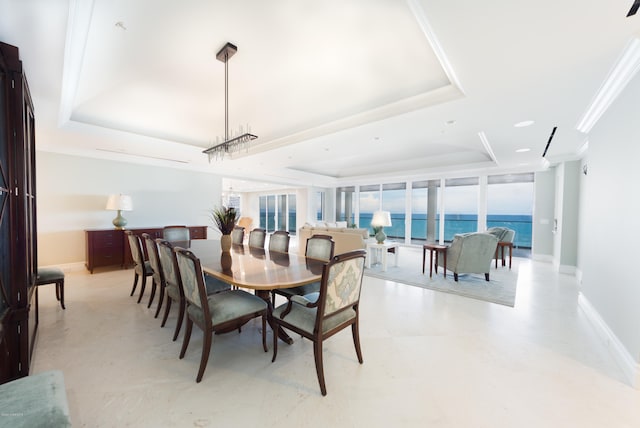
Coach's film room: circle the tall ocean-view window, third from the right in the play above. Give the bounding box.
[411,180,440,243]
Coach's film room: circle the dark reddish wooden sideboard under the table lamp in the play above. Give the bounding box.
[85,226,207,273]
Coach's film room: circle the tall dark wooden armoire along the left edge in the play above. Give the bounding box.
[0,43,38,383]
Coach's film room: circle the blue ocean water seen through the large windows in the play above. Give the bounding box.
[358,213,532,248]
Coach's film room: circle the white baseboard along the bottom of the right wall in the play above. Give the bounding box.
[578,293,640,389]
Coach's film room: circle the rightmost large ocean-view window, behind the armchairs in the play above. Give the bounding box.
[487,173,534,248]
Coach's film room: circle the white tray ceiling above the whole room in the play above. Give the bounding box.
[0,0,640,190]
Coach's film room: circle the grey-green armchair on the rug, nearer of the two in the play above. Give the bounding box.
[438,232,498,281]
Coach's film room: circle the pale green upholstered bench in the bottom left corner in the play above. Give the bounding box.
[0,370,71,428]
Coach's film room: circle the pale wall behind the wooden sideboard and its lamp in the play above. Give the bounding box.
[36,152,222,266]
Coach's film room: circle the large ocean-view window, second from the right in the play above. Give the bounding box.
[444,177,479,242]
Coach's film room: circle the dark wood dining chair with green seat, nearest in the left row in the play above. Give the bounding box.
[174,247,267,382]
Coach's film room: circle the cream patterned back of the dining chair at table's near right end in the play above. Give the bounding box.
[316,250,367,322]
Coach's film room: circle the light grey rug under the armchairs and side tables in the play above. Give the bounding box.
[364,247,518,307]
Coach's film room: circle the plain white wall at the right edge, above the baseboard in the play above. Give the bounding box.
[579,72,640,370]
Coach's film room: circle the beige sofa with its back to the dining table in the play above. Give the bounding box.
[298,221,369,254]
